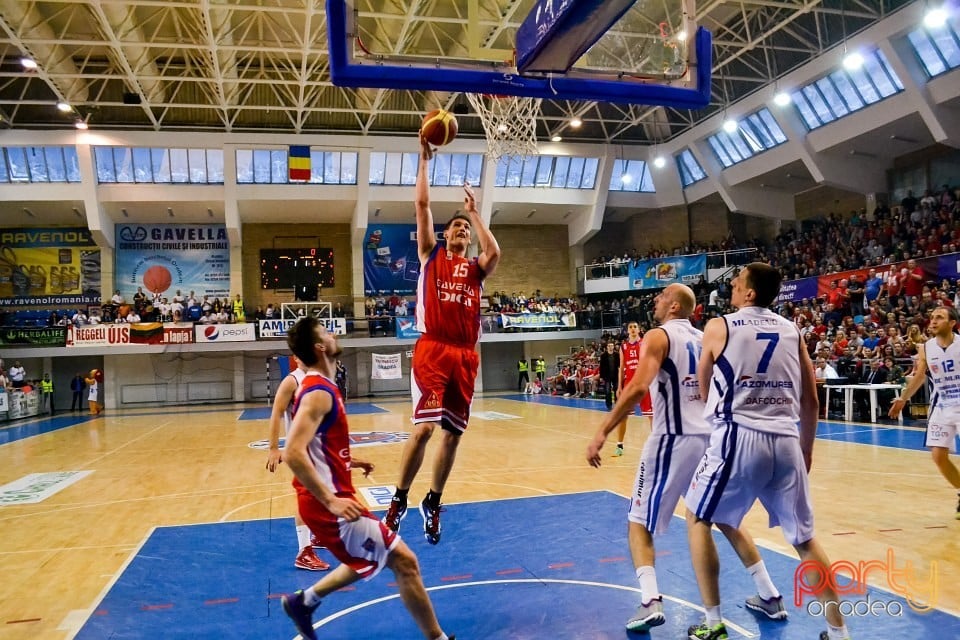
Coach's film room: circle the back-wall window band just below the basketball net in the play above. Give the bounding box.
[494,156,600,191]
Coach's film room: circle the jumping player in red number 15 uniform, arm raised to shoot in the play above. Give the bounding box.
[383,138,500,544]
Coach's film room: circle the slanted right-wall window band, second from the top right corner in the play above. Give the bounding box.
[791,49,903,131]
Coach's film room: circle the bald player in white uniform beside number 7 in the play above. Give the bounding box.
[587,284,787,632]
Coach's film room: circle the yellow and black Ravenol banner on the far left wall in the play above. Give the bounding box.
[0,227,101,311]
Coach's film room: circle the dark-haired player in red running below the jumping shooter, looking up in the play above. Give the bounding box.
[281,317,454,640]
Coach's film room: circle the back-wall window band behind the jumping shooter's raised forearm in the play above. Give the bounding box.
[372,151,483,187]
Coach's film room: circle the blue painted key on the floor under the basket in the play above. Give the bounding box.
[76,492,960,640]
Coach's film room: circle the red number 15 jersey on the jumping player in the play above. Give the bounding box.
[417,244,486,348]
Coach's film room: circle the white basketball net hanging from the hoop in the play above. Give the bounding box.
[467,93,542,161]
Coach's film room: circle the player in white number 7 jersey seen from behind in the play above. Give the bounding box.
[684,262,849,640]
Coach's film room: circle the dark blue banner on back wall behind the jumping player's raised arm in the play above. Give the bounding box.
[363,224,443,295]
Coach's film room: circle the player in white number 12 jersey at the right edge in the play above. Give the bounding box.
[890,307,960,520]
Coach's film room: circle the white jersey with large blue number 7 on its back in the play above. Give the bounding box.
[707,307,801,436]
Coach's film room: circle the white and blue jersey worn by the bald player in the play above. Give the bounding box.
[650,319,712,435]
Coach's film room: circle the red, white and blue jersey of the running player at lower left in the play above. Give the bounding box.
[293,371,354,496]
